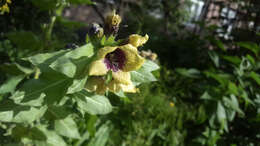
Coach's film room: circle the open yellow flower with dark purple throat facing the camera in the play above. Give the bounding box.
[89,44,144,85]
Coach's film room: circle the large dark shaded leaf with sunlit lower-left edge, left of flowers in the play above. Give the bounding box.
[10,72,72,106]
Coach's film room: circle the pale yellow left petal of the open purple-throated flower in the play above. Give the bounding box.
[89,59,108,76]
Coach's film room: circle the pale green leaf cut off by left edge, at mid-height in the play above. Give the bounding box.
[0,75,25,94]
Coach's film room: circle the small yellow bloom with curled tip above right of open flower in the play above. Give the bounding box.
[128,34,149,47]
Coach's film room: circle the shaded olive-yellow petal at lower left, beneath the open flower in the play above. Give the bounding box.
[86,77,107,95]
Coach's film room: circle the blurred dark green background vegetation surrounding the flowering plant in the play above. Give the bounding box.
[0,0,260,146]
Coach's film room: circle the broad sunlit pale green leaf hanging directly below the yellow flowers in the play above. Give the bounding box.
[74,90,112,115]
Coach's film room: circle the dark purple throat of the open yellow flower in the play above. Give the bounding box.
[104,48,126,72]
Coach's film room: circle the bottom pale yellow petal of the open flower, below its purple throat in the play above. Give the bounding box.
[112,70,131,85]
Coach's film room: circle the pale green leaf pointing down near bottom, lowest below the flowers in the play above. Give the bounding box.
[55,117,80,139]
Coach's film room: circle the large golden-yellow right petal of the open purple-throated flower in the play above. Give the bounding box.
[119,44,145,72]
